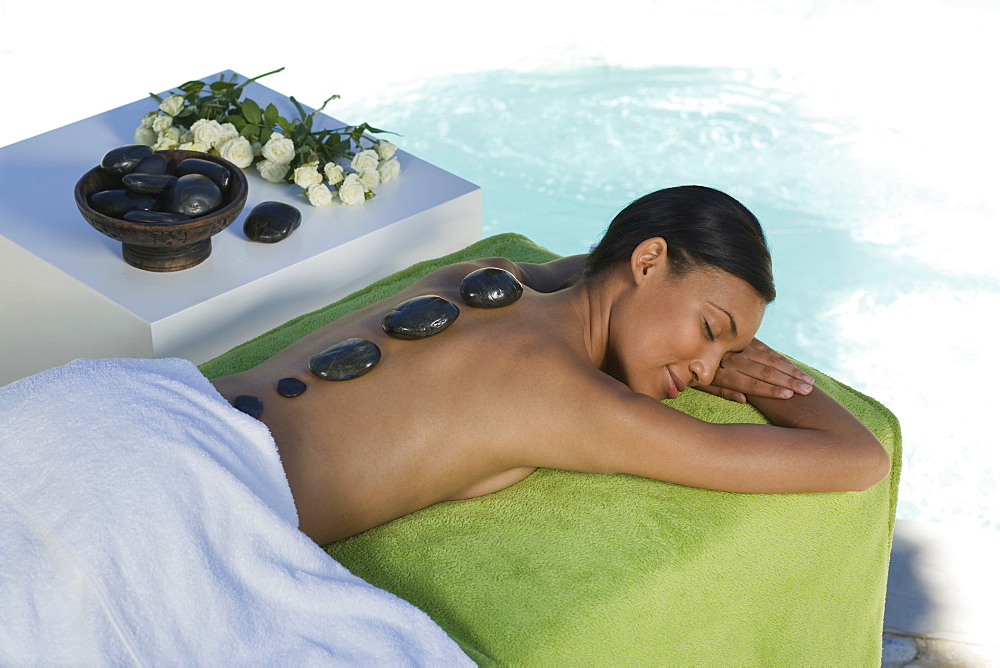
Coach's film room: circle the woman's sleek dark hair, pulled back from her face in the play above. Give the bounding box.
[584,186,775,304]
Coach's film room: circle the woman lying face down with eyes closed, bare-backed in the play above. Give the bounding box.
[212,186,890,544]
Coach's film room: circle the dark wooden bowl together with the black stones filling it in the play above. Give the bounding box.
[74,144,248,271]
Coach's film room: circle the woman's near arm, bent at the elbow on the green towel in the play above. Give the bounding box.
[538,368,891,494]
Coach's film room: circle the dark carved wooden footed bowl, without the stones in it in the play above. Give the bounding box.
[74,150,249,271]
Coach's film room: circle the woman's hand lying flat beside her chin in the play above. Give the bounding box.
[698,339,815,404]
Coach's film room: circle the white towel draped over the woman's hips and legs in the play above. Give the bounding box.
[0,359,471,665]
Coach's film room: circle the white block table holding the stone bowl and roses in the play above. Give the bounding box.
[0,71,482,385]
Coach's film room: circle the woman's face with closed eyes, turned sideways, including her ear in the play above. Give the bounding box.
[606,267,765,400]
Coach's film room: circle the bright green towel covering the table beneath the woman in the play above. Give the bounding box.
[202,234,901,666]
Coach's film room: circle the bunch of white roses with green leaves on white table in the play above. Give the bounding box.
[135,67,400,206]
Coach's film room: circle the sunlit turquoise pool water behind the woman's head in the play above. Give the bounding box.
[332,65,1000,529]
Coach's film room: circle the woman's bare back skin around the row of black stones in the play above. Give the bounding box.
[213,260,593,543]
